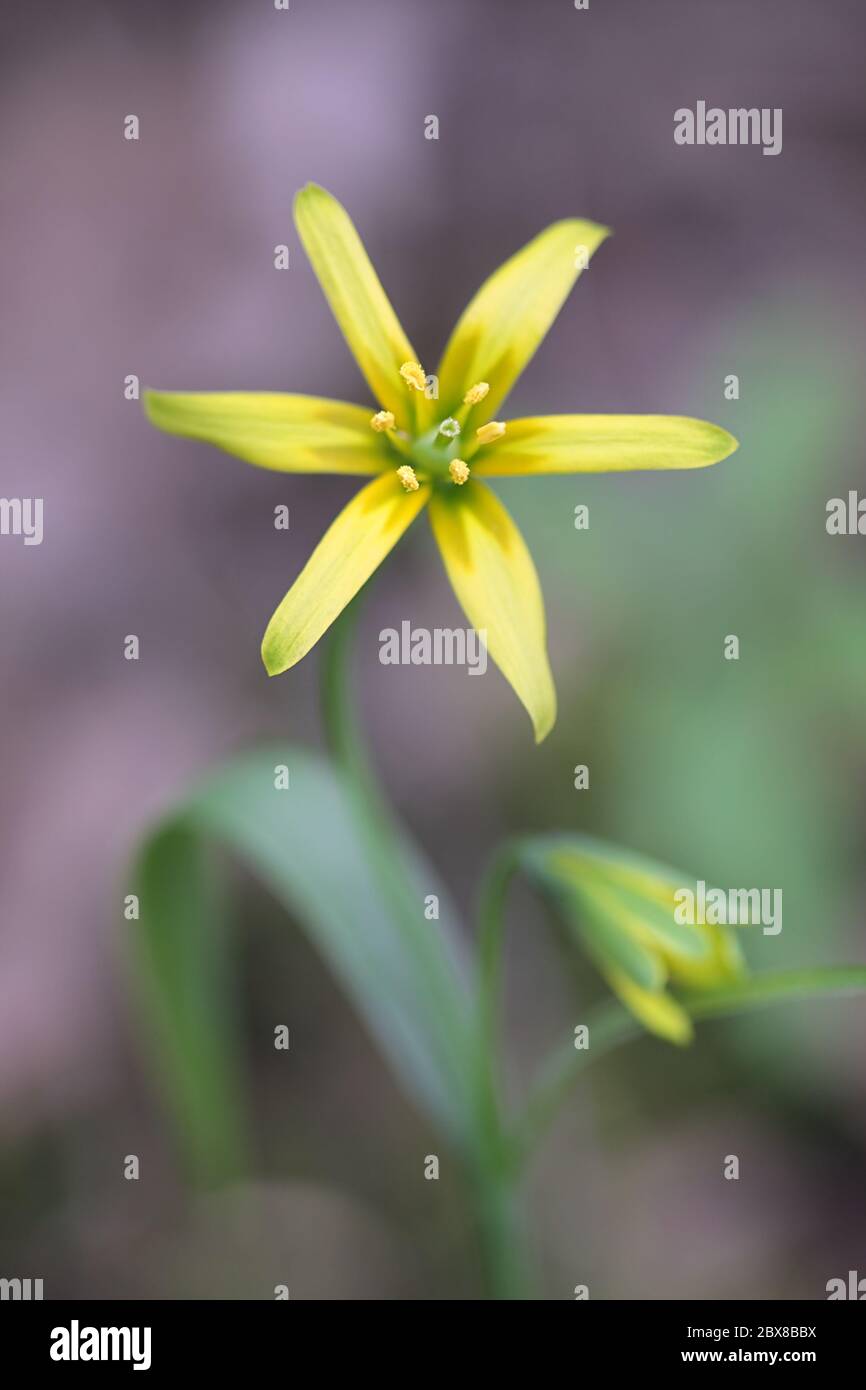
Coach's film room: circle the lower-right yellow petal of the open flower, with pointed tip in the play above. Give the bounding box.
[430,478,556,742]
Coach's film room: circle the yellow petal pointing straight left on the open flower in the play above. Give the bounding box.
[145,391,392,474]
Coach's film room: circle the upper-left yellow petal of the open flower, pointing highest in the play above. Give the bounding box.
[295,183,431,432]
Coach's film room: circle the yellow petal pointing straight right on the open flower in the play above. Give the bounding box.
[473,416,738,478]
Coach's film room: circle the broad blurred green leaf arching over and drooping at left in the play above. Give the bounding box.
[132,745,477,1179]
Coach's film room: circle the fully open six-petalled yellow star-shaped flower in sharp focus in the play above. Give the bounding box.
[145,183,737,741]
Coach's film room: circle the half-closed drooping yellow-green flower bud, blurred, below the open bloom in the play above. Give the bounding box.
[521,835,745,1044]
